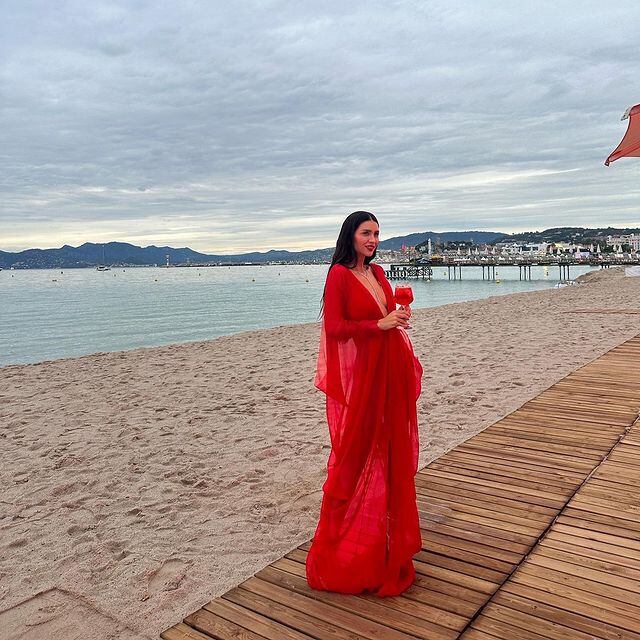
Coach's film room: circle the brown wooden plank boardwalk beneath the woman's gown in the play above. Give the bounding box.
[161,336,640,640]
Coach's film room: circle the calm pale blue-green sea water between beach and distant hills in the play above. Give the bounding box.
[0,265,589,366]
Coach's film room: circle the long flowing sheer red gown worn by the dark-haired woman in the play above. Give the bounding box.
[306,264,422,596]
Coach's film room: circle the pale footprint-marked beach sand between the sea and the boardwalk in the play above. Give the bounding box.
[0,269,640,640]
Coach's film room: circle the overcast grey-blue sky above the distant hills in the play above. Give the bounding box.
[0,0,640,253]
